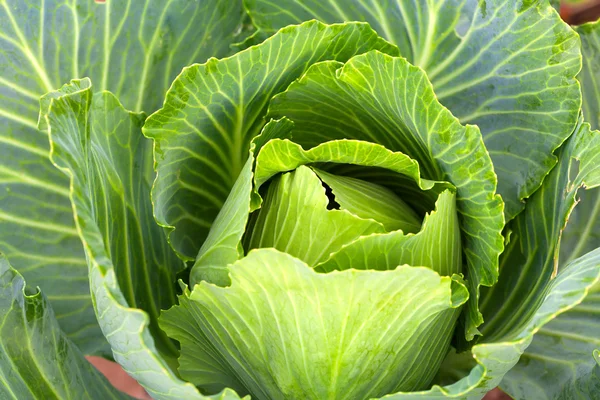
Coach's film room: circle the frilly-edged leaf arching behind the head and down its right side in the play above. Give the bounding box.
[264,51,504,339]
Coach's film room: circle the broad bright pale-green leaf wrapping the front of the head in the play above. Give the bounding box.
[161,249,468,399]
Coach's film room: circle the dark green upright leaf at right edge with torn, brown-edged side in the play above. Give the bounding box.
[481,119,600,342]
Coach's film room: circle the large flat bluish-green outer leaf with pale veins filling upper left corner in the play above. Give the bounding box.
[0,0,243,355]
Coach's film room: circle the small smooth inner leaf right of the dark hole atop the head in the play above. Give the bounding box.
[315,170,421,233]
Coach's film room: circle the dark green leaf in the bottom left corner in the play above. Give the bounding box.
[0,254,128,400]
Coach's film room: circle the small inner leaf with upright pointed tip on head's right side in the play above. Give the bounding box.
[316,190,462,276]
